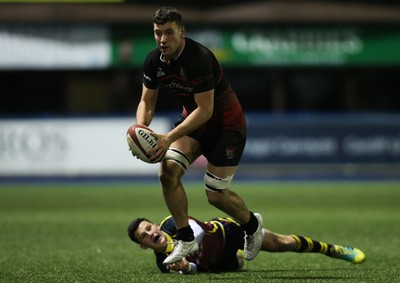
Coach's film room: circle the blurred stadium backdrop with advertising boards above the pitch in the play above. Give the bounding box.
[0,0,400,182]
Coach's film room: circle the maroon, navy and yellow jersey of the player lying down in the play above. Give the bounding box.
[155,216,244,272]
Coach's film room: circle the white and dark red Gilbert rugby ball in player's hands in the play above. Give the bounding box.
[126,125,156,163]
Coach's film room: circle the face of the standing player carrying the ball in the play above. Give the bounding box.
[153,22,185,60]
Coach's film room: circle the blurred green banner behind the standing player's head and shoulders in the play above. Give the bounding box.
[112,26,400,67]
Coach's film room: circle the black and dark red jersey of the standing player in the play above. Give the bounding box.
[143,38,246,136]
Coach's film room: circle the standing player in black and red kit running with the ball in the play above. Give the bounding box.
[136,7,262,265]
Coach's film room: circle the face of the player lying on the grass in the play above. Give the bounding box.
[135,221,168,253]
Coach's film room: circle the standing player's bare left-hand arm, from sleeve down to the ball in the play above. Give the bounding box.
[136,84,158,126]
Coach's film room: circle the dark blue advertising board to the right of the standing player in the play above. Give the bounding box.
[242,114,400,163]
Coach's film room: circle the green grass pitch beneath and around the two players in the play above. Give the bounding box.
[0,181,400,283]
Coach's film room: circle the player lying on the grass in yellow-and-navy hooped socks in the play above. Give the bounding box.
[128,216,366,274]
